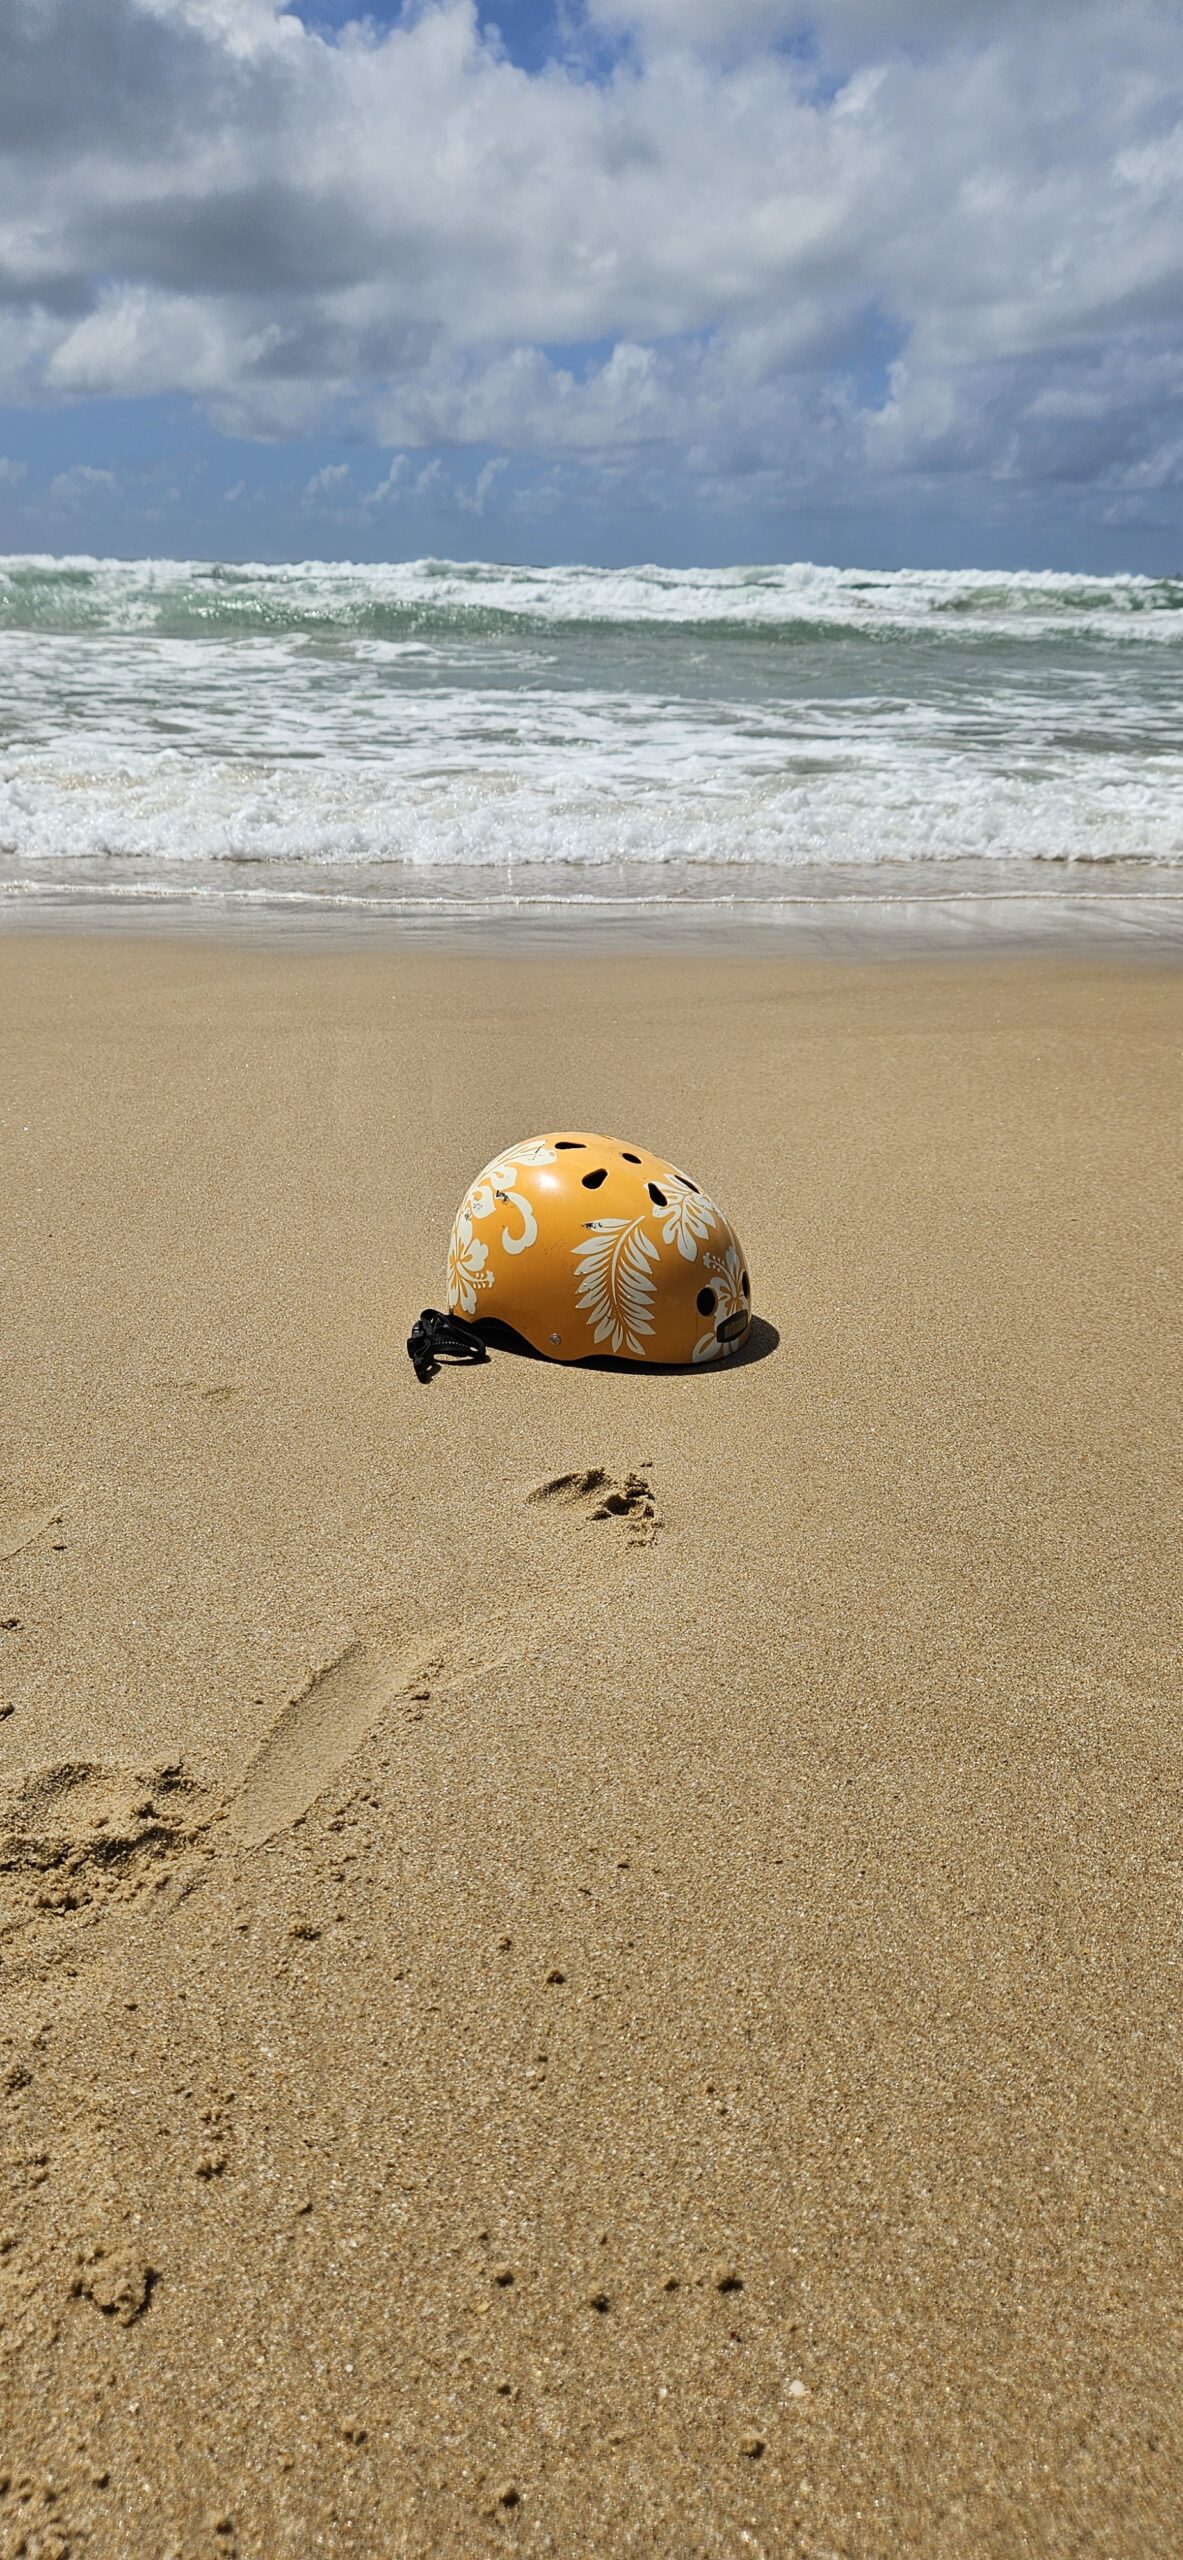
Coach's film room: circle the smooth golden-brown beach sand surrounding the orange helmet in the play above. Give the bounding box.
[0,937,1183,2560]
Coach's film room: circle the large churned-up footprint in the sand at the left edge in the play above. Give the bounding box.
[0,1761,218,1964]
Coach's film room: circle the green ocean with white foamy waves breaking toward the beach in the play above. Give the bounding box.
[0,558,1183,914]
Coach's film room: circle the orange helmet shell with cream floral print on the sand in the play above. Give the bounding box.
[437,1129,753,1364]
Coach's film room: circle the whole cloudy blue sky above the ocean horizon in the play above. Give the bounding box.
[0,0,1183,573]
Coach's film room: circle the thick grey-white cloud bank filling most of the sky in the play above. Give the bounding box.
[0,0,1183,522]
